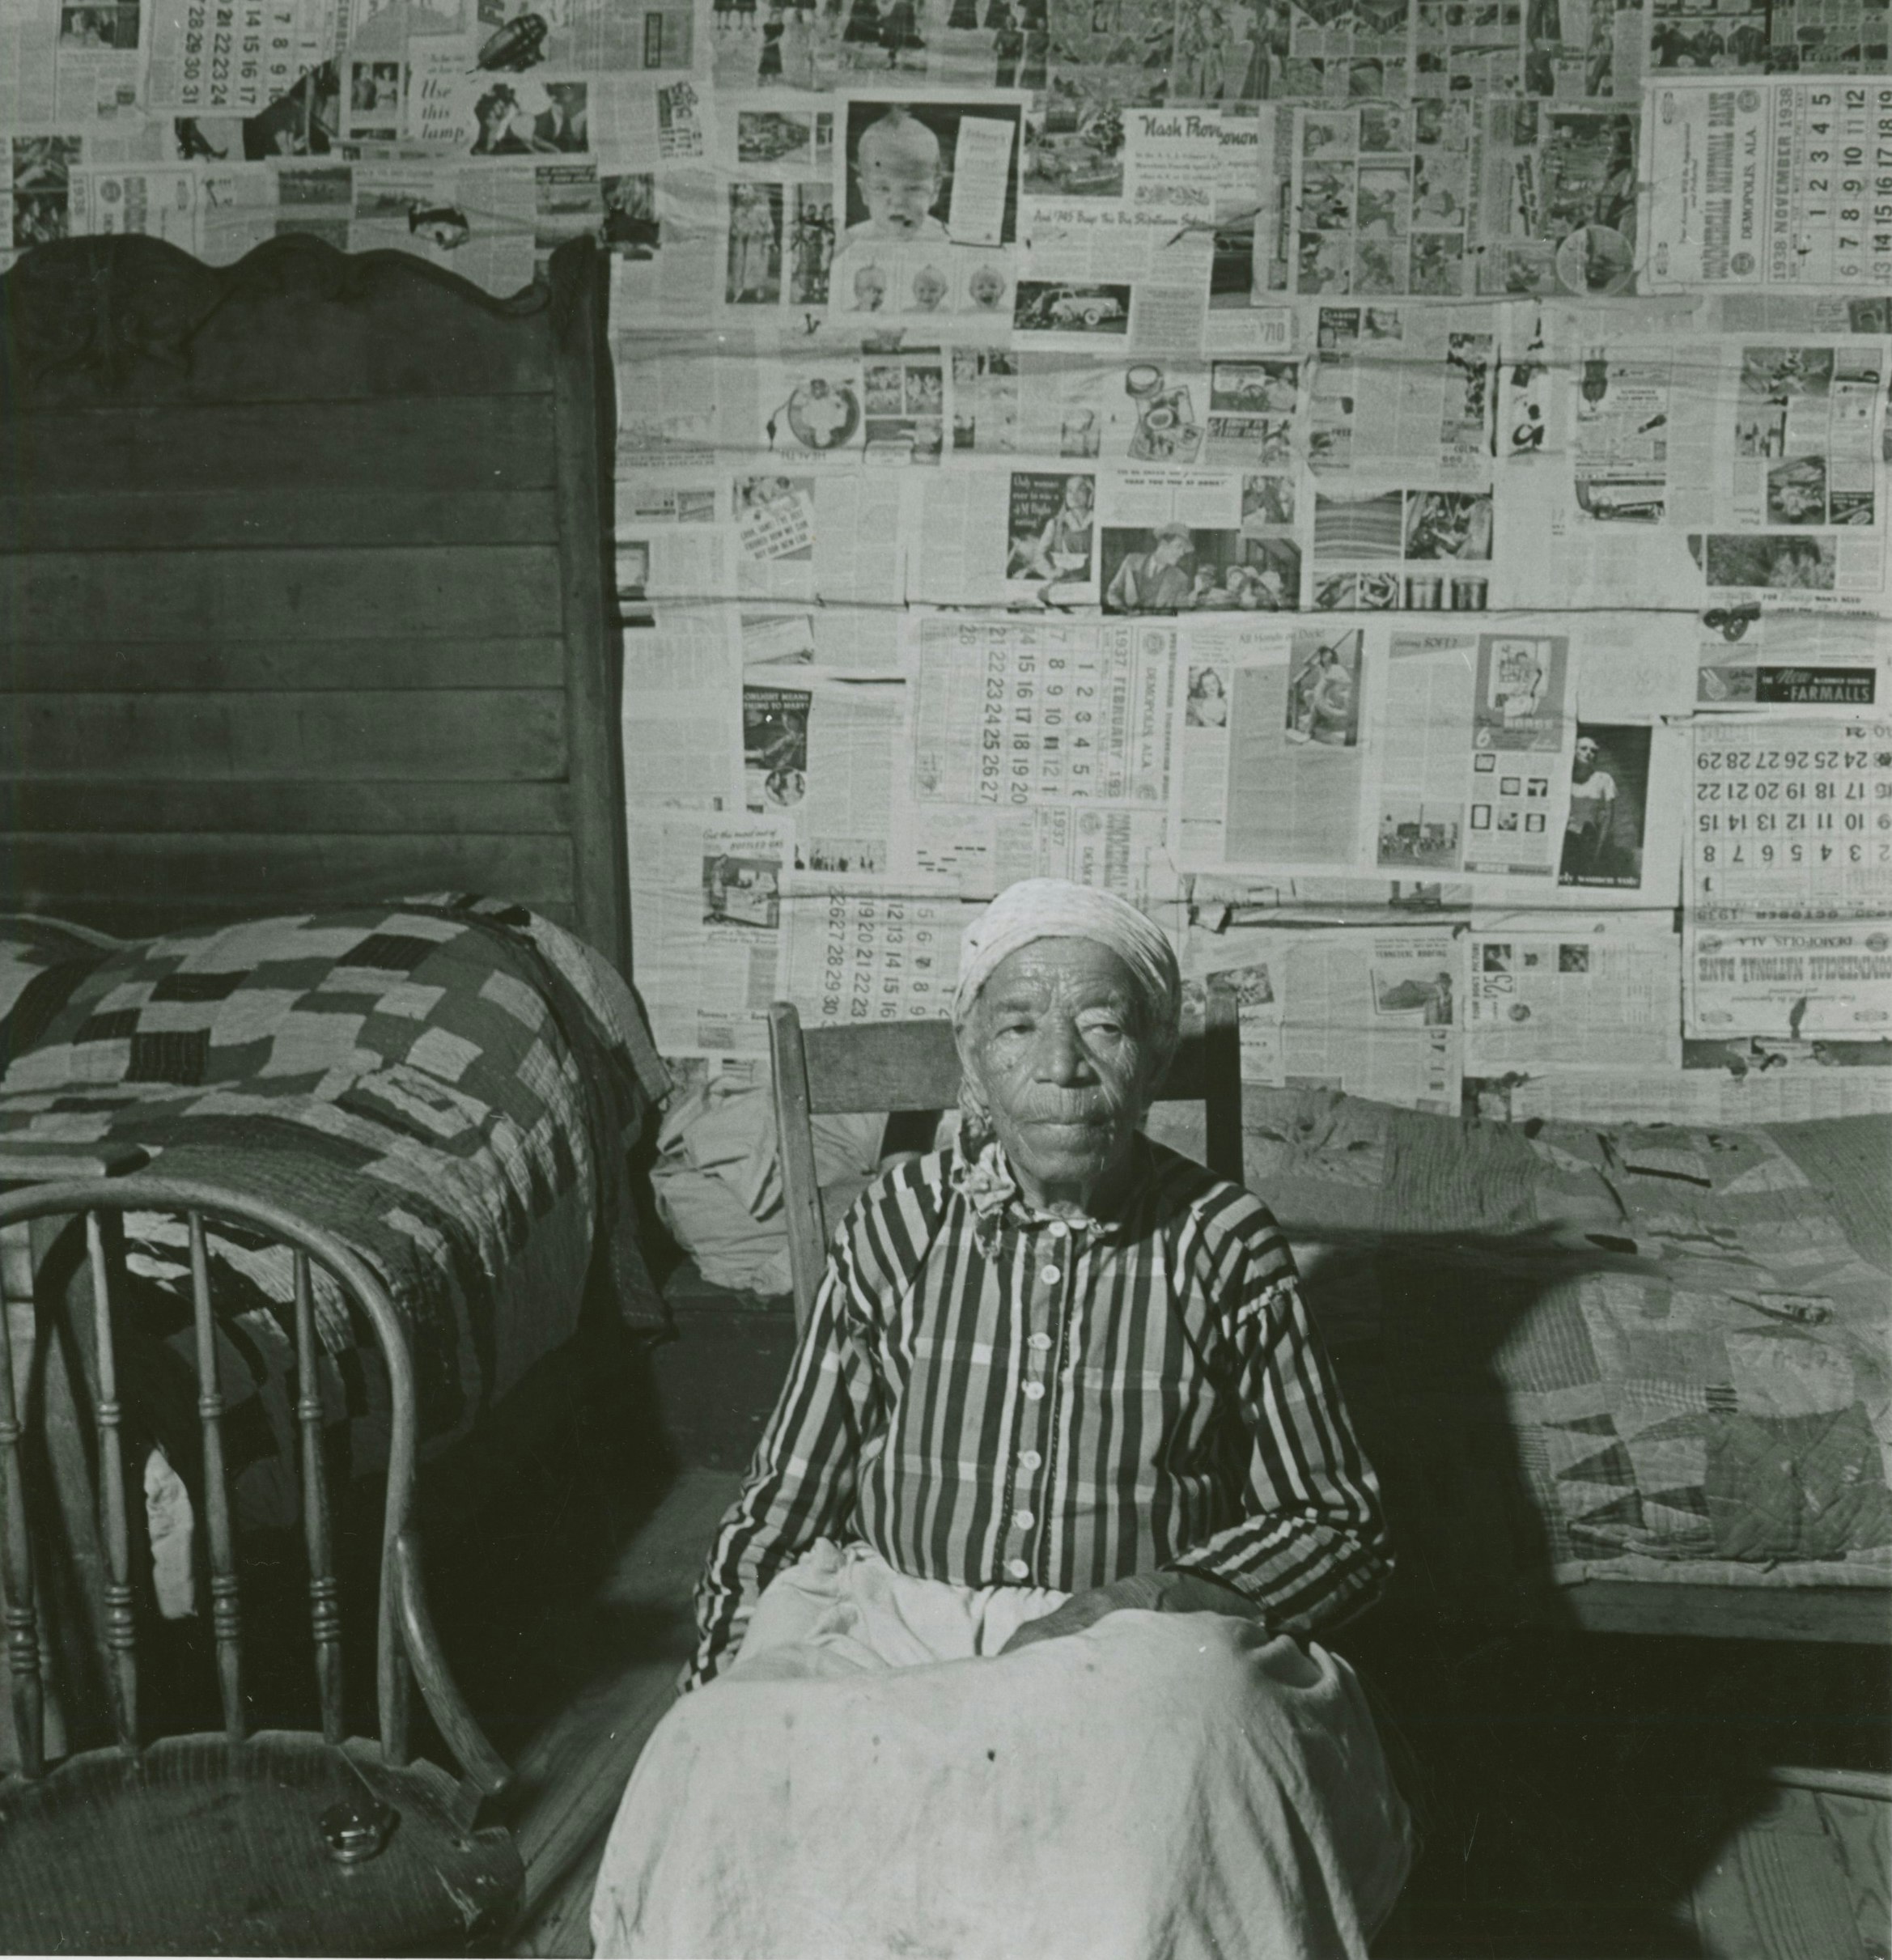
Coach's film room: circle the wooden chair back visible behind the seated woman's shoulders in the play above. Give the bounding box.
[769,974,1241,1329]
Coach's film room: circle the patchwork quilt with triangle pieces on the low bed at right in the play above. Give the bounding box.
[1152,1090,1892,1597]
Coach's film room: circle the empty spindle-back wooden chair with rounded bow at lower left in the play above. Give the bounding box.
[0,1174,524,1954]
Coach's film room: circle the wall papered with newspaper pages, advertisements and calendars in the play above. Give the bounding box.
[0,0,1892,1121]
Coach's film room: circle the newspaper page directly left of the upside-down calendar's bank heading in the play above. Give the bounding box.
[1465,914,1682,1076]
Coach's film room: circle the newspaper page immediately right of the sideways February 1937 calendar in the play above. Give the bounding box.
[1177,616,1384,870]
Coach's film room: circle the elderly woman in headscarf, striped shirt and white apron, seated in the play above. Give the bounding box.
[592,880,1410,1960]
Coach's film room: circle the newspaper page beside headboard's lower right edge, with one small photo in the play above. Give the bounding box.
[630,812,788,1054]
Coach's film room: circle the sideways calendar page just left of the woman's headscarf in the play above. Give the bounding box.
[783,874,965,1027]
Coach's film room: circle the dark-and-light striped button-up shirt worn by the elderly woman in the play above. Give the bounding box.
[686,1137,1390,1686]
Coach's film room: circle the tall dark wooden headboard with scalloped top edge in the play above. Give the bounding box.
[0,235,630,972]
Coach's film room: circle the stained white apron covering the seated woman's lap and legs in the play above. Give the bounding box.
[592,1542,1410,1960]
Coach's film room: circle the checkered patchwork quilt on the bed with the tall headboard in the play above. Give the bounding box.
[0,893,667,1525]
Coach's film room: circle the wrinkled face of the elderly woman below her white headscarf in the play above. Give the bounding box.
[959,939,1159,1203]
